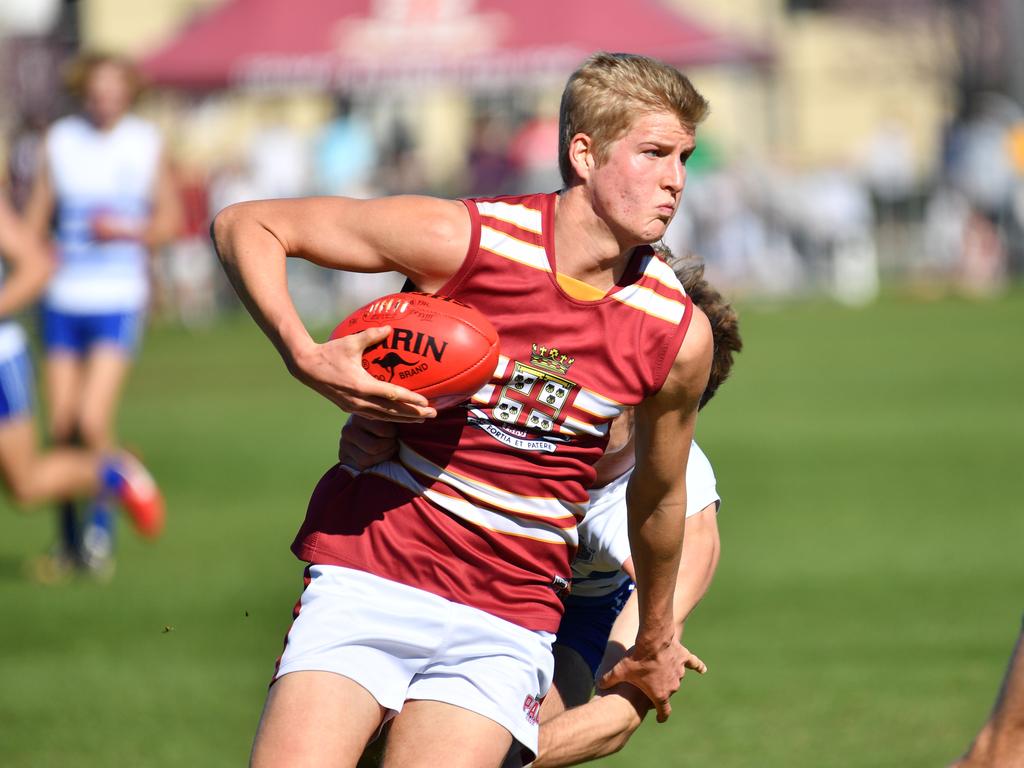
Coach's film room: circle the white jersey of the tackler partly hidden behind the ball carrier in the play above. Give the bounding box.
[572,442,722,597]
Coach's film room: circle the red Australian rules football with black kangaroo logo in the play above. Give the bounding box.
[331,293,498,409]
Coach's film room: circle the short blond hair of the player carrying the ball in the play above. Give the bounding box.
[558,52,709,185]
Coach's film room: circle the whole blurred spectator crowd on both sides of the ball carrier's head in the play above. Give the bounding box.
[7,64,1024,325]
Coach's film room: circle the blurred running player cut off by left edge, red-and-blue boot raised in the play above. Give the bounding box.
[0,197,164,581]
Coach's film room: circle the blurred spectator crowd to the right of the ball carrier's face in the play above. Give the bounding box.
[667,97,1024,304]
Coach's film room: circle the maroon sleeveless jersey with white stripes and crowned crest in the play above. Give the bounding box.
[293,194,692,632]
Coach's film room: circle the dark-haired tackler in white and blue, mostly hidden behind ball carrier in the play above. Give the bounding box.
[516,258,742,768]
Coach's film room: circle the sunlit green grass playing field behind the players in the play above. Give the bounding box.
[0,290,1024,768]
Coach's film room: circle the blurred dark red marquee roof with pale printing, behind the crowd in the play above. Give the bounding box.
[141,0,765,89]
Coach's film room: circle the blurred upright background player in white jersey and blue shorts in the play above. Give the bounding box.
[27,56,180,563]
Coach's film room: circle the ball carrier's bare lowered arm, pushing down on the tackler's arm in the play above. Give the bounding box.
[599,307,713,722]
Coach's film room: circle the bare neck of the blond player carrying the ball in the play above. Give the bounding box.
[555,184,634,293]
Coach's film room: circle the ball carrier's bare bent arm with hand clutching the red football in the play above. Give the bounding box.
[213,197,471,421]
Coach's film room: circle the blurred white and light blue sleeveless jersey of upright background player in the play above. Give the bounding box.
[46,116,161,314]
